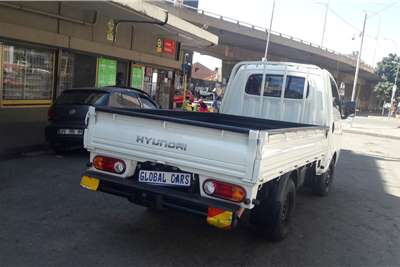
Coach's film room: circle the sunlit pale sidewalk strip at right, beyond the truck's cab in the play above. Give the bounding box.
[343,116,400,140]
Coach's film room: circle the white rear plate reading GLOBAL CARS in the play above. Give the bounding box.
[138,170,192,186]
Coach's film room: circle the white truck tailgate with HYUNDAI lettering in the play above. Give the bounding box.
[84,108,258,180]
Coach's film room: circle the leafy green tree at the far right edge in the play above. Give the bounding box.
[374,54,400,102]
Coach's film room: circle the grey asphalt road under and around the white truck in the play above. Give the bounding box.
[0,134,400,266]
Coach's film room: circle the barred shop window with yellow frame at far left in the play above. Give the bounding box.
[1,45,54,103]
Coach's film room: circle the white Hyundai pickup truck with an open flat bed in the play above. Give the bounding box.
[81,62,351,240]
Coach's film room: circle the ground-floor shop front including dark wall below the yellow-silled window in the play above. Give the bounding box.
[0,40,182,152]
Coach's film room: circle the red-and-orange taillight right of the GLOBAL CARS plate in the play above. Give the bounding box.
[203,179,246,202]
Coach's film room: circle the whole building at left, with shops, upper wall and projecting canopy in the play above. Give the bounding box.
[0,1,218,154]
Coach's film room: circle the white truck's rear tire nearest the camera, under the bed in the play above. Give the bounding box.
[250,178,296,241]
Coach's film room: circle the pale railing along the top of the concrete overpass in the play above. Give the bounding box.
[165,0,374,71]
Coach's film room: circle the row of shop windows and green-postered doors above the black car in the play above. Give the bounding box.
[0,41,175,111]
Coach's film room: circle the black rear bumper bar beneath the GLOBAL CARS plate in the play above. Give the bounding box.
[83,171,240,216]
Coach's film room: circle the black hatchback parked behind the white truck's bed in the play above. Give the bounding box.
[45,87,157,151]
